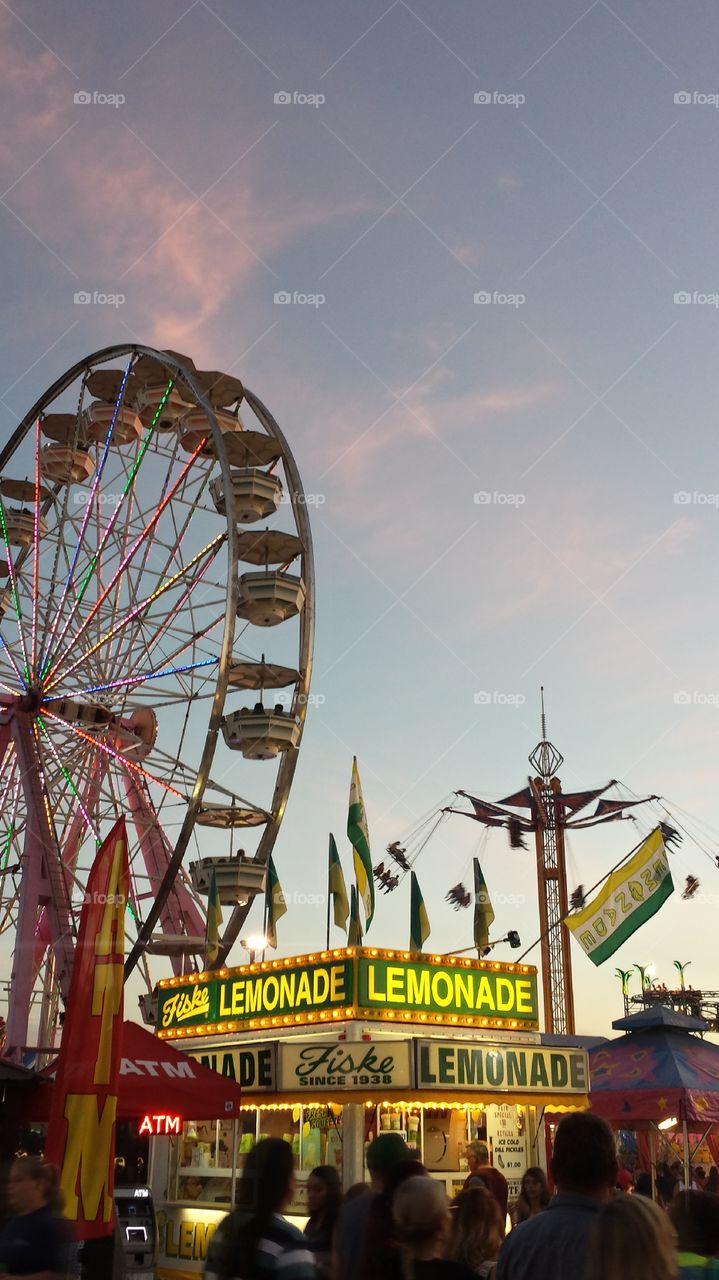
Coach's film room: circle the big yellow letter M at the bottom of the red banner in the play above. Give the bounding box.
[60,1093,118,1222]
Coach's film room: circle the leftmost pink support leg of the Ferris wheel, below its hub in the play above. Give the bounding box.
[6,708,73,1052]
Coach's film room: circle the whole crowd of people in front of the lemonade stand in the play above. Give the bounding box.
[205,1112,719,1280]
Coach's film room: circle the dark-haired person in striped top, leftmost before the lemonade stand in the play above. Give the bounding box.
[205,1138,313,1280]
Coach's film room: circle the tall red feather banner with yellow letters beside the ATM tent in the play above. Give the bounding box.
[45,818,129,1240]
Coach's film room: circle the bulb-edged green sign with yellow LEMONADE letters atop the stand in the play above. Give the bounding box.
[157,947,537,1038]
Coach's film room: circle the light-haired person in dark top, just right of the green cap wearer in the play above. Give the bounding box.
[385,1175,476,1280]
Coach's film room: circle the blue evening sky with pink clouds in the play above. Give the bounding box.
[0,0,719,1034]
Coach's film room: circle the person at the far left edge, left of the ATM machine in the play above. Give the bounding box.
[0,1156,74,1280]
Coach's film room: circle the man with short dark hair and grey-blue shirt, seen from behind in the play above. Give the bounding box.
[496,1111,616,1280]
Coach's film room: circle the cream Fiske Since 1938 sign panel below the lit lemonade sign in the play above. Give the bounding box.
[279,1041,412,1093]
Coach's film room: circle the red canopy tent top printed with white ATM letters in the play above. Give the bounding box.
[26,1021,242,1120]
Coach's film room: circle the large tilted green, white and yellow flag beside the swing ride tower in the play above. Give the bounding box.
[563,827,674,962]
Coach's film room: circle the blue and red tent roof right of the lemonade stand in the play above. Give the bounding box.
[590,1005,719,1129]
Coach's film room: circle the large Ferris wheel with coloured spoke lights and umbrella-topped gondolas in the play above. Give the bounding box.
[0,346,315,1051]
